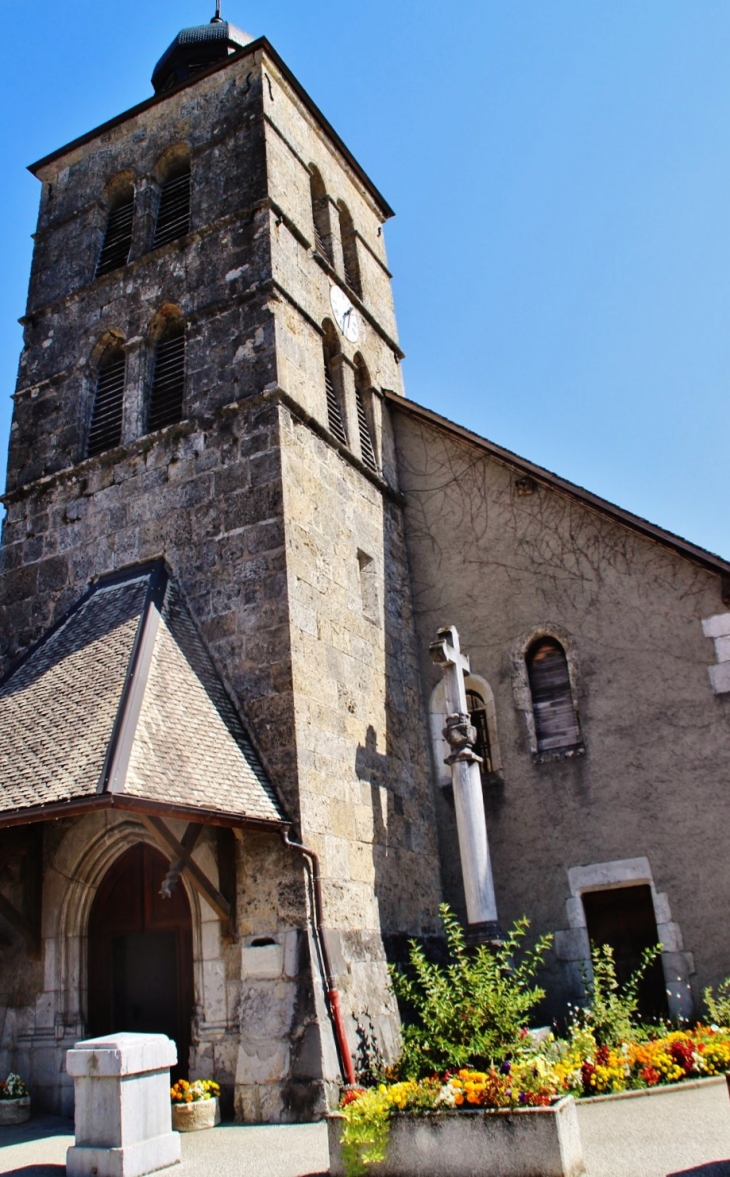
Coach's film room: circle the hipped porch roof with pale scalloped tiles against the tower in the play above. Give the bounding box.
[0,563,288,826]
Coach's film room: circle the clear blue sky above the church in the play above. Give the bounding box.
[0,0,730,557]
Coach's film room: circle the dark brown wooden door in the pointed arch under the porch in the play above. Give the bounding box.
[88,843,193,1079]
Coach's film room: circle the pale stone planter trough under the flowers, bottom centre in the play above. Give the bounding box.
[329,1096,585,1177]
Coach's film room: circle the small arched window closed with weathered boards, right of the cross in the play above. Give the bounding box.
[525,637,580,752]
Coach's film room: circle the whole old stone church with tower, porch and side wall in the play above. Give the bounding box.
[0,4,730,1123]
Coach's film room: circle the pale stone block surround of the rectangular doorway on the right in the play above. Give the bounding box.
[555,858,695,1020]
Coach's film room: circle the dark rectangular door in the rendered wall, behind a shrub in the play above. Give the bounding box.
[583,885,668,1018]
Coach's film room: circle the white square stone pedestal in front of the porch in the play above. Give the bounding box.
[66,1033,180,1177]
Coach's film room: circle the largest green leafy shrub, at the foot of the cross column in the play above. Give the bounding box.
[391,904,552,1078]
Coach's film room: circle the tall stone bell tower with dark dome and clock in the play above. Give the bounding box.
[0,2,440,1121]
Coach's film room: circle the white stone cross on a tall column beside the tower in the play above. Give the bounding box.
[430,625,502,944]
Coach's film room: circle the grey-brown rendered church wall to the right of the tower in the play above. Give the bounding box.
[393,408,730,1011]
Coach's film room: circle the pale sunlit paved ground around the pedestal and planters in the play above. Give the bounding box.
[0,1082,730,1177]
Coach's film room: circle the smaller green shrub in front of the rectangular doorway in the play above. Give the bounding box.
[571,944,662,1046]
